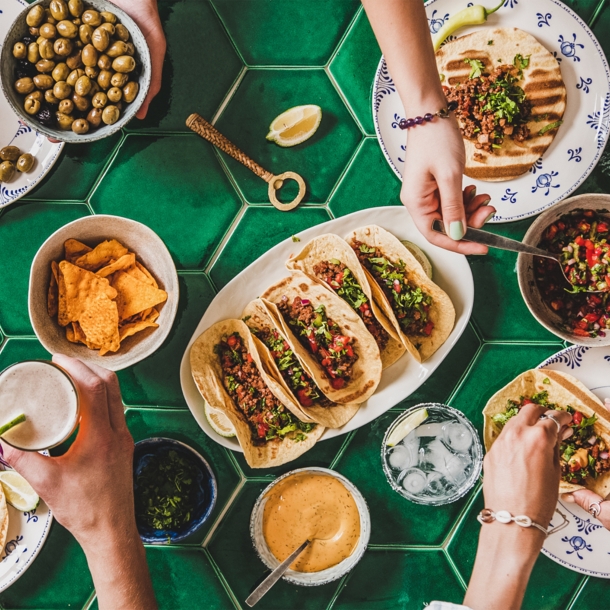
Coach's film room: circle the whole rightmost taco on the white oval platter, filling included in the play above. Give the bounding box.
[347,225,455,362]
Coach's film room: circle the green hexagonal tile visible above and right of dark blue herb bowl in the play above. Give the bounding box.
[125,409,241,544]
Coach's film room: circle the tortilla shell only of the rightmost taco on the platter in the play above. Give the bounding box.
[347,225,455,362]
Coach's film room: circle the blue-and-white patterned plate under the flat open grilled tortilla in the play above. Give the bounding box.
[373,0,610,222]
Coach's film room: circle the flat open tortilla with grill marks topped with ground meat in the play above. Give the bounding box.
[436,28,567,182]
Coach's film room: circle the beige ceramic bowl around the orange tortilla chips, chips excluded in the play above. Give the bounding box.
[28,214,179,371]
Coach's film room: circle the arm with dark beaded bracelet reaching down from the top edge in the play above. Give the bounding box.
[362,0,495,254]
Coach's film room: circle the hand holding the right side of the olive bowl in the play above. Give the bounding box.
[112,0,167,119]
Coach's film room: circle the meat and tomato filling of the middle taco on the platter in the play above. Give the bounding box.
[277,297,358,390]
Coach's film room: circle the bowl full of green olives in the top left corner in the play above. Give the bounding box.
[0,0,151,143]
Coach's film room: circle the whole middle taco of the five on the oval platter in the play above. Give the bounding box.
[261,271,382,404]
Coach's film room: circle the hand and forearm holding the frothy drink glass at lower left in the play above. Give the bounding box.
[2,355,157,610]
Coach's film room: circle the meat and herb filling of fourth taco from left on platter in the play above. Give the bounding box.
[313,261,390,351]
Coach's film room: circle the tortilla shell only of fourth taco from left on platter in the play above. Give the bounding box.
[286,233,405,369]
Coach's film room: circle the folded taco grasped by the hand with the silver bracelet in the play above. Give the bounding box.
[483,369,610,498]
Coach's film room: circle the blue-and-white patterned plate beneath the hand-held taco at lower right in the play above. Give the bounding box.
[540,345,610,576]
